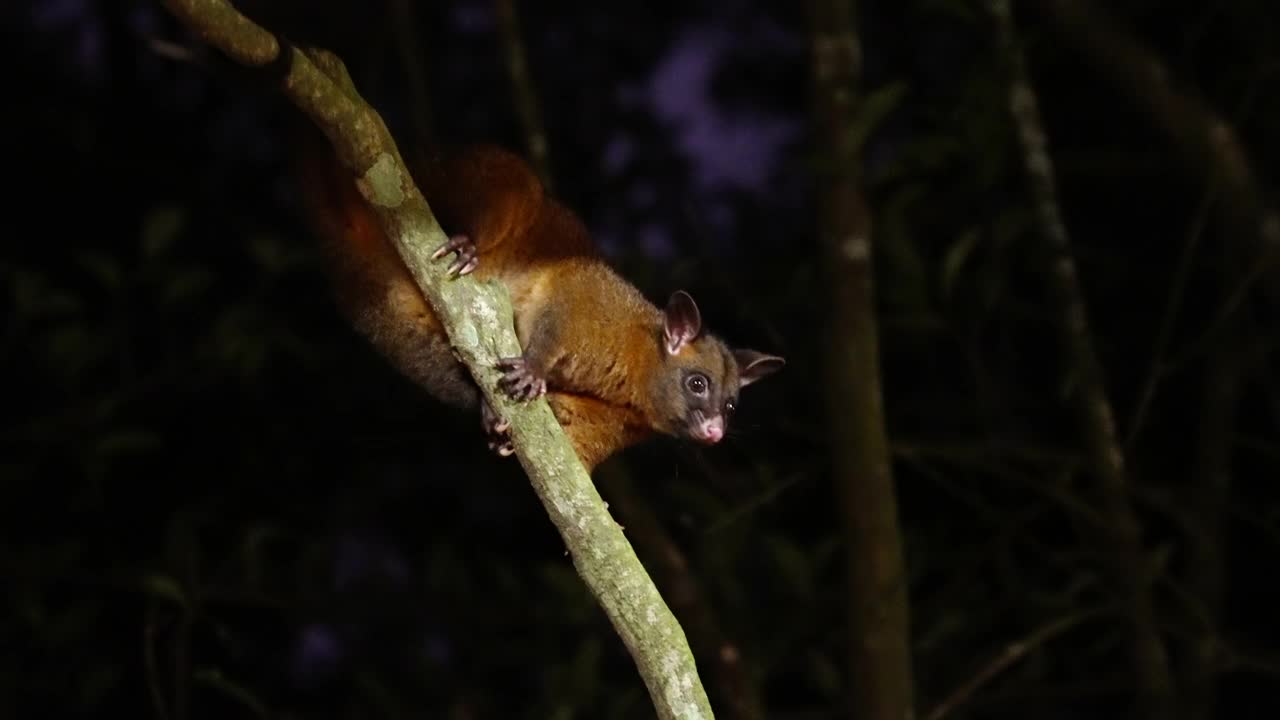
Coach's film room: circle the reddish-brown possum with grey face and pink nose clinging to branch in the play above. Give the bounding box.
[305,145,783,470]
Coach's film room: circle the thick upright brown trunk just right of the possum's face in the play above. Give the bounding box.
[810,0,914,720]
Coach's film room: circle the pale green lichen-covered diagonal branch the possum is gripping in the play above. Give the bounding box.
[165,0,713,720]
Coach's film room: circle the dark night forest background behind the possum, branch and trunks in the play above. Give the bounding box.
[0,0,1280,720]
